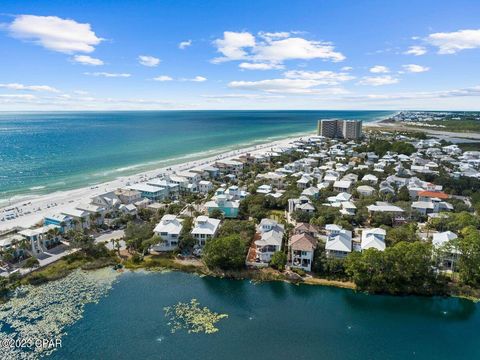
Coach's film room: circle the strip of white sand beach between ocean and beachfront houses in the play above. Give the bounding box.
[0,134,313,231]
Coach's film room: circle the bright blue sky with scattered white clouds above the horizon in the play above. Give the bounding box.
[0,0,480,111]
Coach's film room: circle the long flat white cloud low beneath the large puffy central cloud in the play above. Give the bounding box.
[228,79,346,94]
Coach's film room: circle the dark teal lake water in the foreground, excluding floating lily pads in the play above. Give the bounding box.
[51,272,480,360]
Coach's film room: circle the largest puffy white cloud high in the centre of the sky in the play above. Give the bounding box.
[213,31,345,64]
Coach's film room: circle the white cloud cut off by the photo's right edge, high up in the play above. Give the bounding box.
[426,29,480,54]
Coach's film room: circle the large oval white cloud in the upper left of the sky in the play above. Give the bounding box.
[7,15,103,54]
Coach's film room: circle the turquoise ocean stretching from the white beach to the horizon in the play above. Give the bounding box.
[0,111,391,199]
